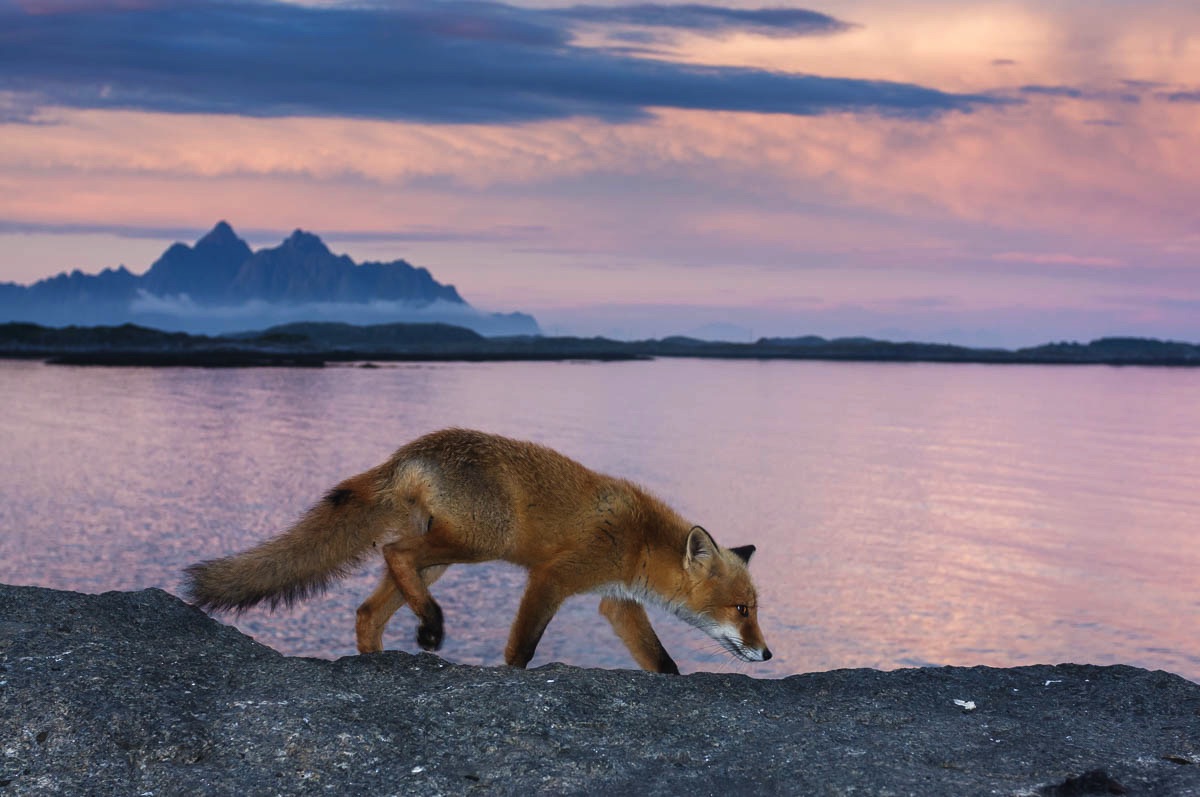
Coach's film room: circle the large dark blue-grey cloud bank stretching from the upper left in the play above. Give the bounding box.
[0,0,1006,124]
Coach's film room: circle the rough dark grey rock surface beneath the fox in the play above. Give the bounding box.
[0,585,1200,797]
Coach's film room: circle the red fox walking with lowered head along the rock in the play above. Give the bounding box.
[185,429,772,673]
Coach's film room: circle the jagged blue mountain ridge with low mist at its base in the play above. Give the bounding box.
[0,221,539,335]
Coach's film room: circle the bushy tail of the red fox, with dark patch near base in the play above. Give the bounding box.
[184,468,395,611]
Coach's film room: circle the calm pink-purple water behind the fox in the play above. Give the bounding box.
[0,360,1200,681]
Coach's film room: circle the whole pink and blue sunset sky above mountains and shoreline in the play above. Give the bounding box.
[0,0,1200,346]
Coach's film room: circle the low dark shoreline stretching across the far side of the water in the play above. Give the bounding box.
[0,323,1200,367]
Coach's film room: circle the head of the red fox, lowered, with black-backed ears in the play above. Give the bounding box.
[677,526,772,661]
